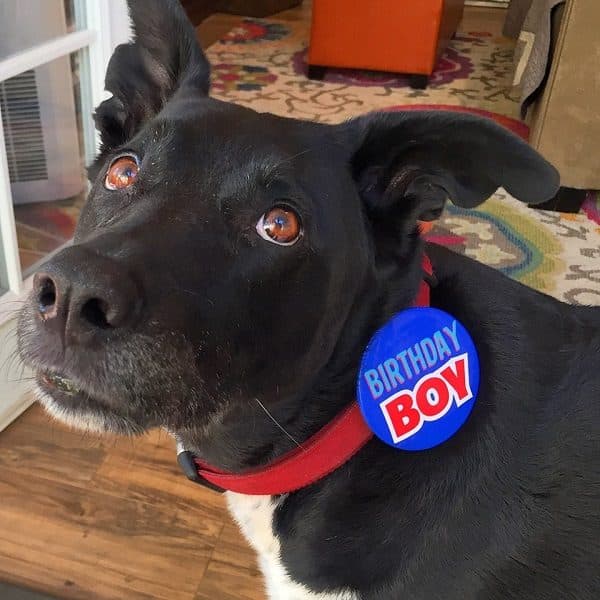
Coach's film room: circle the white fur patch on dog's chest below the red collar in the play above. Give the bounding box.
[226,492,360,600]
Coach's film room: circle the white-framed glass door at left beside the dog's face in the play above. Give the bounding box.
[0,0,129,324]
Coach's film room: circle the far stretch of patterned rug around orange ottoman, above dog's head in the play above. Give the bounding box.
[208,19,519,122]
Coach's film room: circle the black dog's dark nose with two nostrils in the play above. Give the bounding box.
[33,246,140,344]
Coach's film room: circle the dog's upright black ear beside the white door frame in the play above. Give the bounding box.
[94,0,210,157]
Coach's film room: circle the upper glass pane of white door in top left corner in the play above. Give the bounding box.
[0,0,85,60]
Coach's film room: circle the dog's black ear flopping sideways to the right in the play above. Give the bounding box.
[339,110,559,231]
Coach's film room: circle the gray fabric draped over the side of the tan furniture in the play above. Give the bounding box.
[514,0,565,116]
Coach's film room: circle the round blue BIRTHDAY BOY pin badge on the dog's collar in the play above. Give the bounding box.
[358,307,479,450]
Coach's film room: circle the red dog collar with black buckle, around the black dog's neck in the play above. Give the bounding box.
[177,255,433,496]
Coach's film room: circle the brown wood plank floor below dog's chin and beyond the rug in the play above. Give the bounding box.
[0,2,501,600]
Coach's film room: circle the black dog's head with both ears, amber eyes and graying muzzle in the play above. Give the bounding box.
[19,0,557,454]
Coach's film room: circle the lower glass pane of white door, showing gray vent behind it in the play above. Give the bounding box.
[0,51,92,277]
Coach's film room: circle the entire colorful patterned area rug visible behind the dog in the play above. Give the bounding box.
[208,19,600,304]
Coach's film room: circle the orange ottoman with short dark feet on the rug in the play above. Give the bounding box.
[308,0,464,87]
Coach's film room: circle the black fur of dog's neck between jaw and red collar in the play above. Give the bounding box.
[177,243,422,472]
